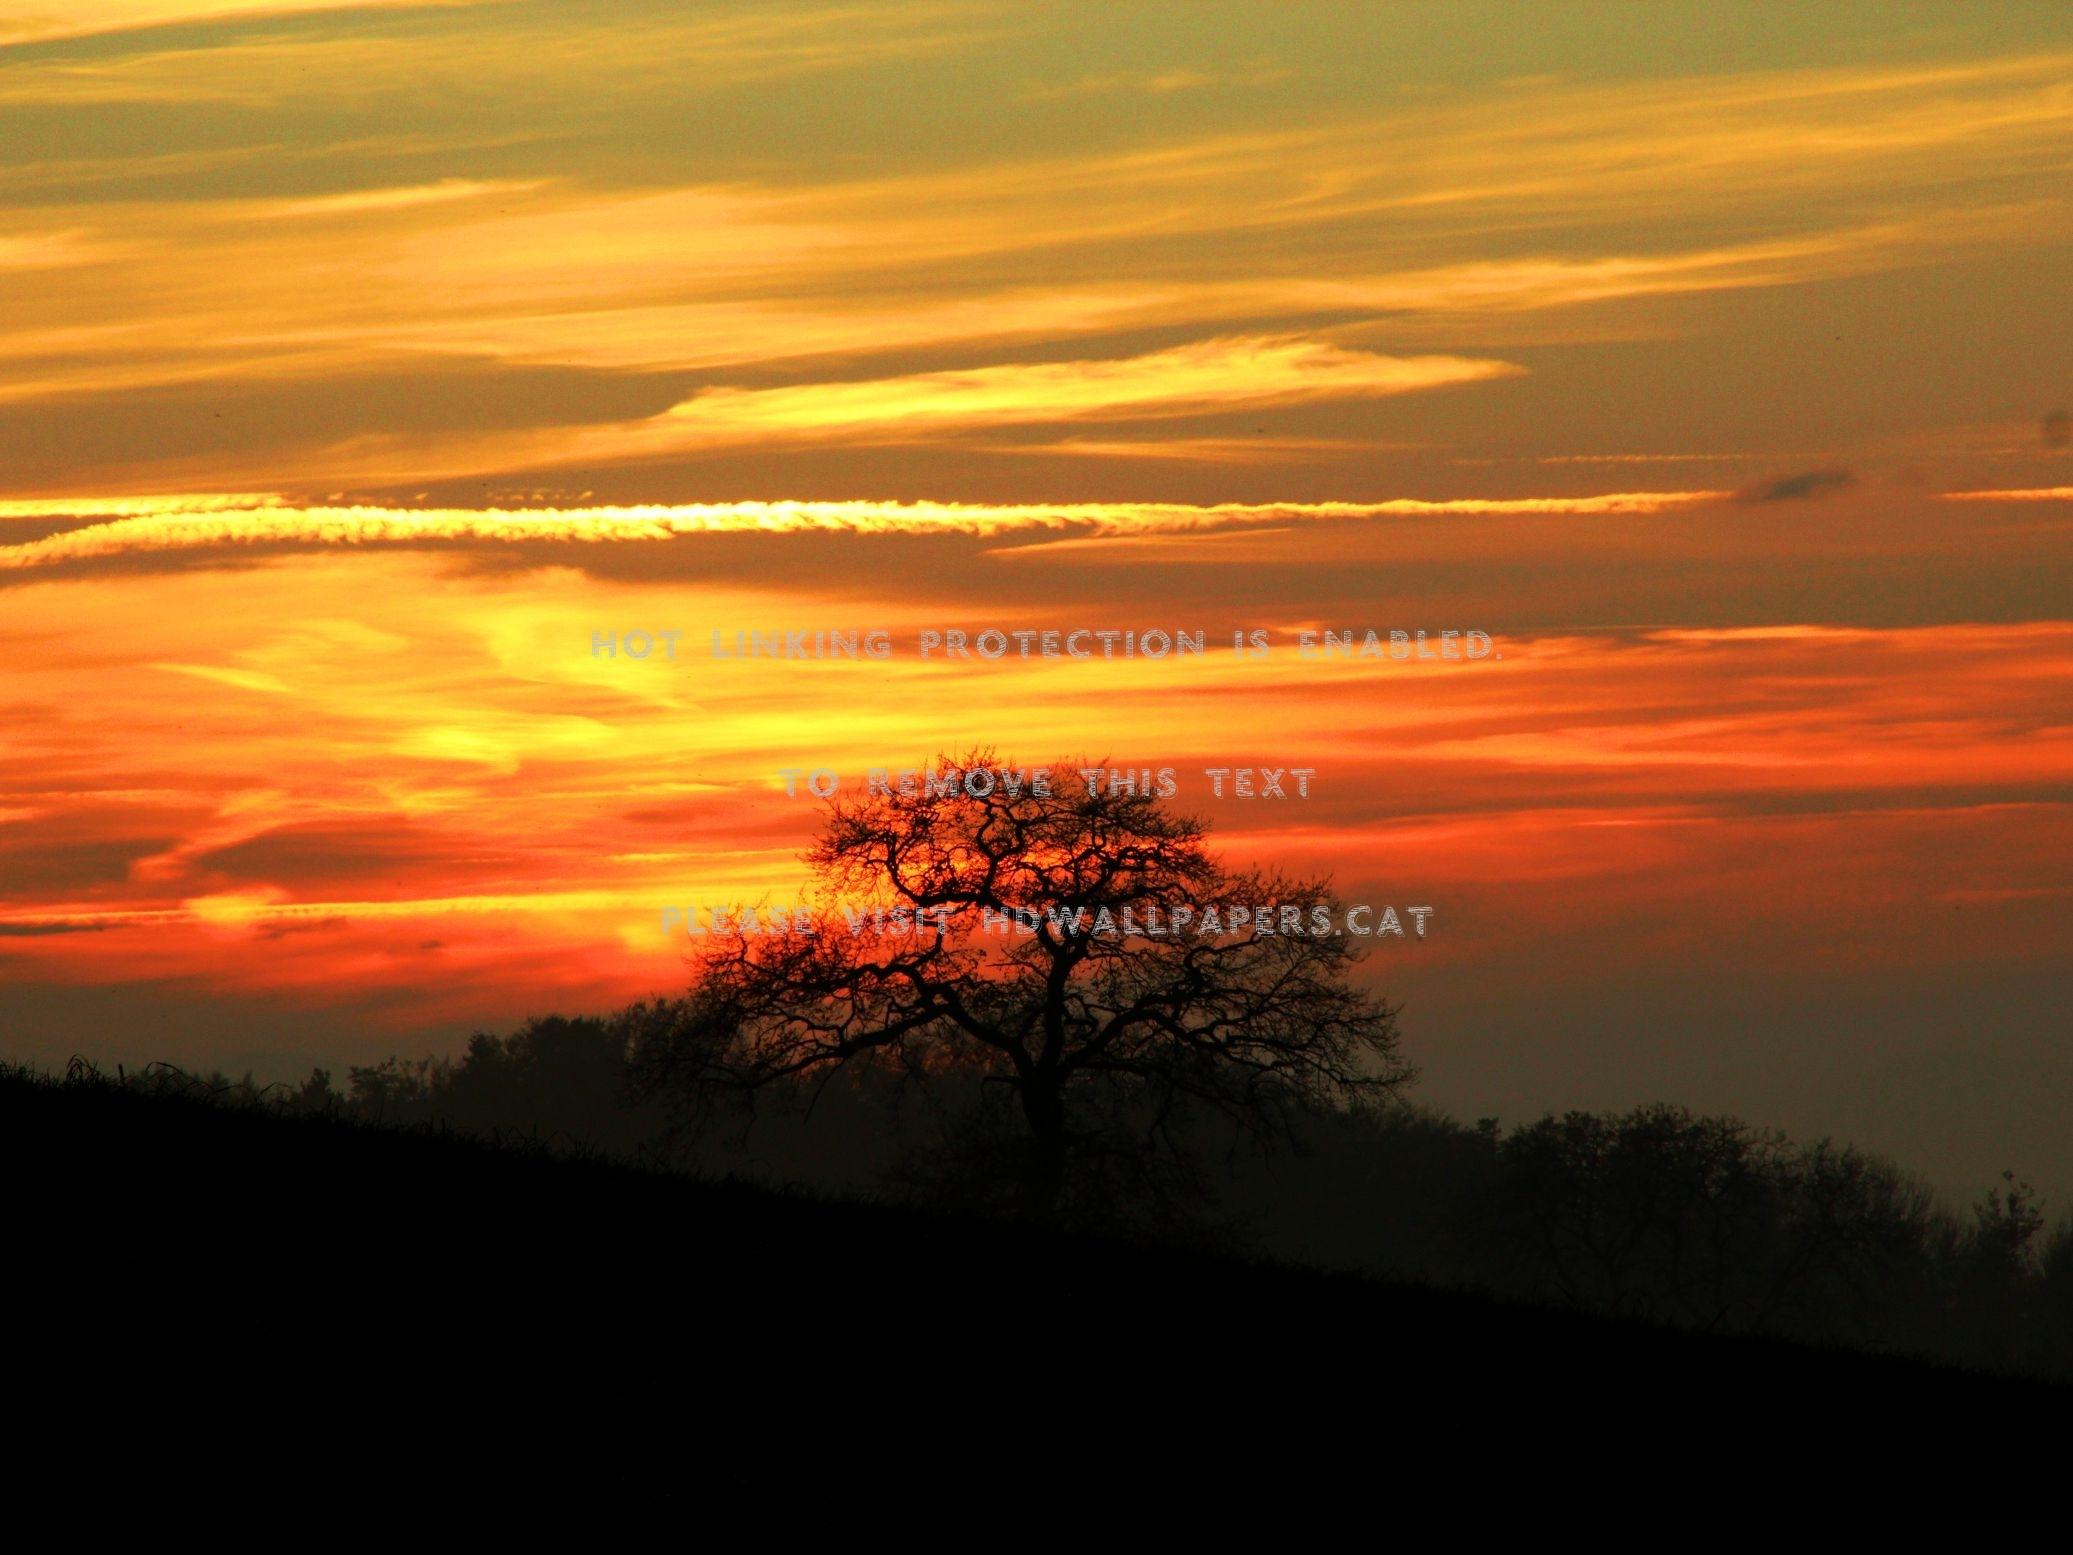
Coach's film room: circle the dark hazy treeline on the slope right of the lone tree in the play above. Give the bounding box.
[1231,1105,2073,1377]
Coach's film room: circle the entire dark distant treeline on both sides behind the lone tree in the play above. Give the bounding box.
[56,1016,2073,1377]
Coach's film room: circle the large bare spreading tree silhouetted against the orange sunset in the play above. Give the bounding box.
[628,751,1412,1213]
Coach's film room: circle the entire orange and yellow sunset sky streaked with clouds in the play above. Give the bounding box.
[0,0,2073,1209]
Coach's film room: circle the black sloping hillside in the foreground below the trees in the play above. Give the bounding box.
[0,1076,2069,1518]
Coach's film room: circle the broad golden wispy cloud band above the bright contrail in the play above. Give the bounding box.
[0,19,2073,491]
